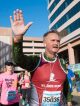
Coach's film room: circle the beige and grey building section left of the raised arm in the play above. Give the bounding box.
[0,27,12,70]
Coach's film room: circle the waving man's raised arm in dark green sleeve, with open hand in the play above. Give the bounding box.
[10,9,39,71]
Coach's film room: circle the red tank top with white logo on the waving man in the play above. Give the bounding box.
[32,58,66,102]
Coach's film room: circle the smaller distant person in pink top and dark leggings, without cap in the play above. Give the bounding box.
[20,71,30,105]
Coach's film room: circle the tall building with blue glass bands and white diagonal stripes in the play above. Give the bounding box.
[48,0,80,64]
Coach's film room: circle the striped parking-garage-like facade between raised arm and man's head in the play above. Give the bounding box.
[23,36,44,55]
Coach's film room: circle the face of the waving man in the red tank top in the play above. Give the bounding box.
[44,33,60,54]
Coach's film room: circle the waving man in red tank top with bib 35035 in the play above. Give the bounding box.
[10,10,71,106]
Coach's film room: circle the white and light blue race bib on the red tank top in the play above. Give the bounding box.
[42,91,61,106]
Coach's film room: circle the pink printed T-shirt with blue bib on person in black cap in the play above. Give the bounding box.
[0,72,20,105]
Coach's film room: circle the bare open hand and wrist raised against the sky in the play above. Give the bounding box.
[10,9,32,43]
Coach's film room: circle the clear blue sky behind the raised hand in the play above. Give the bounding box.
[0,0,49,37]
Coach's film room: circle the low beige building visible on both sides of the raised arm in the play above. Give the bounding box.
[0,27,44,71]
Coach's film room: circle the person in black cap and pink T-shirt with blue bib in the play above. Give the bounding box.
[0,61,20,106]
